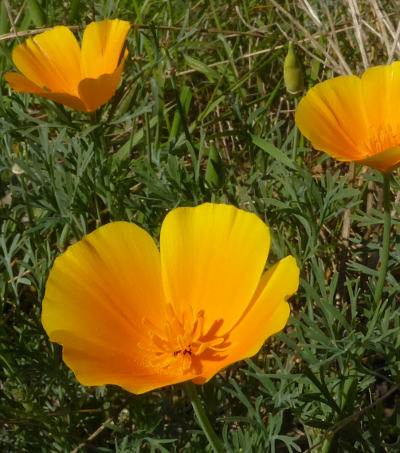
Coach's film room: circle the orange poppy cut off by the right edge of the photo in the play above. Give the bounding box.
[295,61,400,173]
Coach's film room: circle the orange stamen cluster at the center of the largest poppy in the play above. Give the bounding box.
[138,304,228,373]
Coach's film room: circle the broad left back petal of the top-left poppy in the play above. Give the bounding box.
[12,26,81,95]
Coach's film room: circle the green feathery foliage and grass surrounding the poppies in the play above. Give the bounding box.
[0,0,400,453]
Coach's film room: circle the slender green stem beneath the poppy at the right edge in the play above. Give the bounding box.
[374,173,391,304]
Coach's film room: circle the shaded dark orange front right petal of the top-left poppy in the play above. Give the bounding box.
[79,52,128,112]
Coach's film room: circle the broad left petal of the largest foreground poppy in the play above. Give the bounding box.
[42,222,171,392]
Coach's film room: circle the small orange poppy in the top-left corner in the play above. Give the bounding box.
[5,19,130,112]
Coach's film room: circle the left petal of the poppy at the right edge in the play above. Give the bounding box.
[295,76,369,161]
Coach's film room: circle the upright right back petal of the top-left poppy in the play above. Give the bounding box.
[81,19,130,79]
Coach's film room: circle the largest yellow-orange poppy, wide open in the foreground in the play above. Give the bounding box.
[42,204,299,393]
